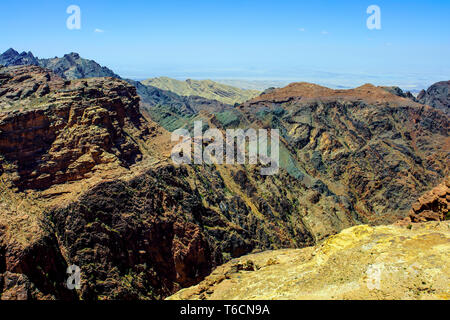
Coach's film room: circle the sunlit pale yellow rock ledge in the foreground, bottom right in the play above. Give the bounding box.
[169,221,450,300]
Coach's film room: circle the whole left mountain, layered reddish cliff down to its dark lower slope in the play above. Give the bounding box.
[0,66,344,300]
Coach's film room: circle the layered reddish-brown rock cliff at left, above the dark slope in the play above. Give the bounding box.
[0,67,158,189]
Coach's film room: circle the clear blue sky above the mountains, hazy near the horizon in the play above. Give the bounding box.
[0,0,450,88]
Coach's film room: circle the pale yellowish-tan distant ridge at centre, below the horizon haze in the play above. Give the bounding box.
[142,77,261,104]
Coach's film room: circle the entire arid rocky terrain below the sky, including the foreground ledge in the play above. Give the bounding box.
[0,50,450,300]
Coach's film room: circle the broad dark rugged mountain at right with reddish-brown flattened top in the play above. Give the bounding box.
[234,83,449,223]
